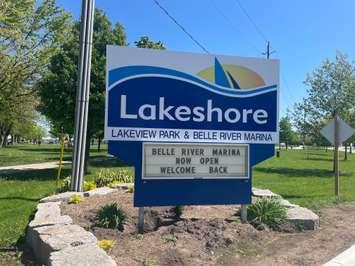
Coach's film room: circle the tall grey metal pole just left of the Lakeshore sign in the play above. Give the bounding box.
[71,0,94,191]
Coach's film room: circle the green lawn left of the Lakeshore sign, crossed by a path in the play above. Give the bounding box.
[0,144,131,249]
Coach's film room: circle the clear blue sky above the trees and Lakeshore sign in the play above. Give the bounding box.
[57,0,355,116]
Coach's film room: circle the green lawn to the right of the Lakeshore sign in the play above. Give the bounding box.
[253,149,355,209]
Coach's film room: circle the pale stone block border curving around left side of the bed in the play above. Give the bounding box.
[26,187,121,266]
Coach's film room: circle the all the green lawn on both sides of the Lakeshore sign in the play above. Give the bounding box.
[0,144,355,264]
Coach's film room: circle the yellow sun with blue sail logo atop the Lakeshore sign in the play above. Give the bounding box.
[197,58,265,90]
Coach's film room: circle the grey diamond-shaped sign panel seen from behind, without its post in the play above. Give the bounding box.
[320,117,355,145]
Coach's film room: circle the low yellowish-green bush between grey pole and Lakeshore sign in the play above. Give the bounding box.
[95,169,133,187]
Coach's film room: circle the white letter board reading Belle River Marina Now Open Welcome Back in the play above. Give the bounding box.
[142,143,249,179]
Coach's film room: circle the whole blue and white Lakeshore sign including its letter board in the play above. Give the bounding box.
[105,46,279,207]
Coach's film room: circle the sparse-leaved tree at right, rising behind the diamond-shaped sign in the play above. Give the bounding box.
[293,52,355,149]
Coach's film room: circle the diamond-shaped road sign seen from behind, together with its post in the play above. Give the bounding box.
[320,115,355,197]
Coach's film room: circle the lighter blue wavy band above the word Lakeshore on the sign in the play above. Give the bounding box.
[108,65,277,95]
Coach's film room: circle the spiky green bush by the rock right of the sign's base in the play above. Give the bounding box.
[248,198,287,229]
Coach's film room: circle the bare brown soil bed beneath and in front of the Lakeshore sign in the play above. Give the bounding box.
[61,191,355,265]
